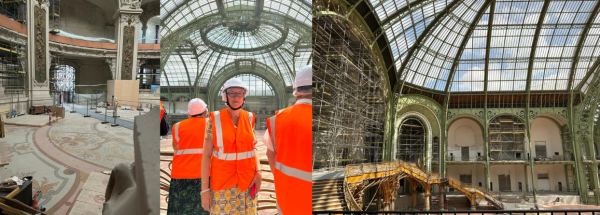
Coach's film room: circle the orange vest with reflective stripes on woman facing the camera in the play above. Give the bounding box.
[210,109,257,191]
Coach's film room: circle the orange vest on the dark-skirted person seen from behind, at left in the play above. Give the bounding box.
[171,117,208,179]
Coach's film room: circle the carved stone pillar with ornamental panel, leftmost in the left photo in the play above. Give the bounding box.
[27,0,52,106]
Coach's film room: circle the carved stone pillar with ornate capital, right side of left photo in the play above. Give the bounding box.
[114,0,142,80]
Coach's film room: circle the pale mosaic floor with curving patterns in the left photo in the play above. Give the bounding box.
[0,112,134,214]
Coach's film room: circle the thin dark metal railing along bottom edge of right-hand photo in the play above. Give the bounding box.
[312,210,600,215]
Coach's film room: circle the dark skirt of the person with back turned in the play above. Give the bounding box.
[167,178,209,215]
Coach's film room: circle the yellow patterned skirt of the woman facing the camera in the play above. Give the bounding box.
[210,186,258,215]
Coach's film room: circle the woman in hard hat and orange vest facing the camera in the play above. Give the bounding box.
[201,78,262,215]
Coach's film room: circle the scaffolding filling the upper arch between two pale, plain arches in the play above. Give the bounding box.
[489,115,526,160]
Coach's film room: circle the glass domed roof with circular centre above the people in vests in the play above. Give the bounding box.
[160,0,312,87]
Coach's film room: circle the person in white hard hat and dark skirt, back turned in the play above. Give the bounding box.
[167,98,209,215]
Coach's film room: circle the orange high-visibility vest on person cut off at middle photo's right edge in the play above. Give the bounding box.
[267,103,312,215]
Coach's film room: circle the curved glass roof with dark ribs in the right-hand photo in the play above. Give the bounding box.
[369,0,600,92]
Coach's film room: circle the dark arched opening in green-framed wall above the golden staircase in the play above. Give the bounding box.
[396,117,427,163]
